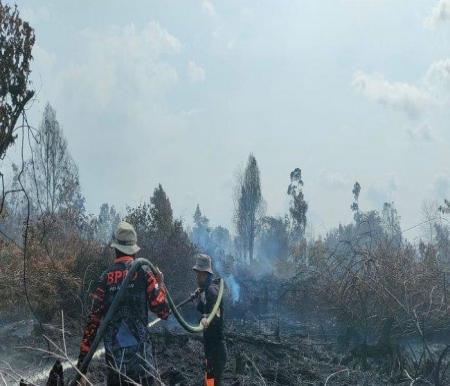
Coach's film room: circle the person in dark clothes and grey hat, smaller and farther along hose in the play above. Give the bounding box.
[193,254,227,386]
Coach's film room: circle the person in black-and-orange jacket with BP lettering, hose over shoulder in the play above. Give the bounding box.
[78,221,169,386]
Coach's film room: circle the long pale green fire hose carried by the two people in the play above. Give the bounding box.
[69,258,224,386]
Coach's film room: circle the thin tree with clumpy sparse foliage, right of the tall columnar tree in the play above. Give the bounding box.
[287,168,308,239]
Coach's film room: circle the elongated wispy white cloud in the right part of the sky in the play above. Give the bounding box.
[352,71,433,118]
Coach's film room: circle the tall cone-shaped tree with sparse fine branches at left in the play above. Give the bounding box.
[28,104,84,215]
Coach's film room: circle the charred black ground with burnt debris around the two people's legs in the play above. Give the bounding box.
[0,316,390,386]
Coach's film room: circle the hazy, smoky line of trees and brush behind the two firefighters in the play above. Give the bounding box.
[0,3,450,384]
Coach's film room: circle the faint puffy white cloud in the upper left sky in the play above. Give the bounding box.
[61,21,182,109]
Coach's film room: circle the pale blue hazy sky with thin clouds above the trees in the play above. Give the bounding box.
[6,0,450,241]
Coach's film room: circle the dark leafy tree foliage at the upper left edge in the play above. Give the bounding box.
[0,2,35,159]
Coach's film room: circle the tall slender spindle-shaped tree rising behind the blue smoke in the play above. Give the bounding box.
[235,154,262,262]
